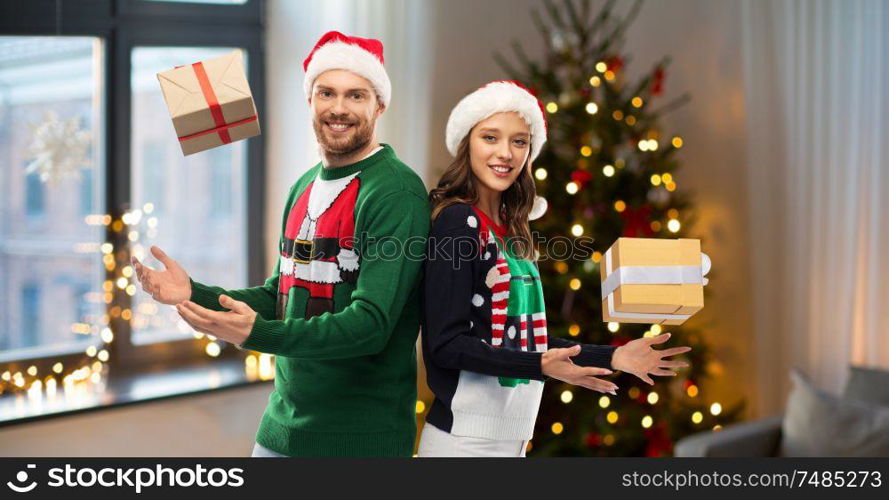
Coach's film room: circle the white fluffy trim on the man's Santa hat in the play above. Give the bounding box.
[303,41,392,106]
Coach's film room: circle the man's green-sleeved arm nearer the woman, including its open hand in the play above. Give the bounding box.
[177,193,429,359]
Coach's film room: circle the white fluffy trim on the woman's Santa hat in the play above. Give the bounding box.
[445,81,546,161]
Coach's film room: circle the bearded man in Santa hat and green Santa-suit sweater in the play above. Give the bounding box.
[133,32,429,457]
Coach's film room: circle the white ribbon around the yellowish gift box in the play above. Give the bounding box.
[602,248,711,321]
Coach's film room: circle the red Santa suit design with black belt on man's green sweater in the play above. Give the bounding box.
[278,172,361,319]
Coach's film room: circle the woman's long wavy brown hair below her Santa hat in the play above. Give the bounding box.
[429,132,537,260]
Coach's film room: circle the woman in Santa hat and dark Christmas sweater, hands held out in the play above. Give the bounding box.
[418,81,690,457]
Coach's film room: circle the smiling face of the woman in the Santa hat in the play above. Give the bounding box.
[469,111,531,194]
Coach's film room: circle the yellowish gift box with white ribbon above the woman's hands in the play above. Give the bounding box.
[599,238,710,325]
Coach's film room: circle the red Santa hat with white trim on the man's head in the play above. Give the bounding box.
[303,31,392,106]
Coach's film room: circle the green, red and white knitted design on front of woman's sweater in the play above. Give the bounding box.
[469,213,547,387]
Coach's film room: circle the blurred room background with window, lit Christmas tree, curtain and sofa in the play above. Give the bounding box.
[0,0,889,456]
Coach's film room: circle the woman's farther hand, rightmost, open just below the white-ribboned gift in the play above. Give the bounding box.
[611,333,691,385]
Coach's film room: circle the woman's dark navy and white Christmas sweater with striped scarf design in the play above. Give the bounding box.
[423,203,615,440]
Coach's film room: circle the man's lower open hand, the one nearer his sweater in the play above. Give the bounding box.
[176,295,256,345]
